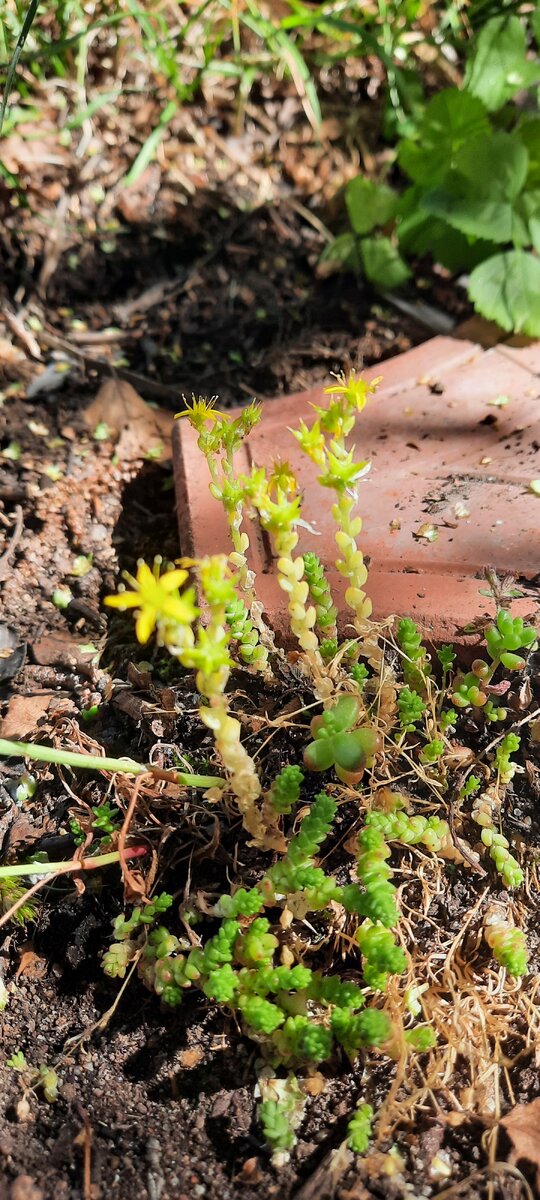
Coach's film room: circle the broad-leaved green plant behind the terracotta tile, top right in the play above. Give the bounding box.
[324,10,540,336]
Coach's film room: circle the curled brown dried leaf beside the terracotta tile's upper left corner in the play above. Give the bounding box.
[84,379,173,462]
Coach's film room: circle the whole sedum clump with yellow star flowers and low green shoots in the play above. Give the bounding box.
[0,364,536,1162]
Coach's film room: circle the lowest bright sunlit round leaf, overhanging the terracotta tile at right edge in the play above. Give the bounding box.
[468,250,540,337]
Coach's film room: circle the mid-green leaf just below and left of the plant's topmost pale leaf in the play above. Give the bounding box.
[397,88,490,187]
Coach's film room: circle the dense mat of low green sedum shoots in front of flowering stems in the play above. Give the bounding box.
[103,792,396,1154]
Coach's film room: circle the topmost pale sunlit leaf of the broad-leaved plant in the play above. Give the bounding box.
[464,16,540,113]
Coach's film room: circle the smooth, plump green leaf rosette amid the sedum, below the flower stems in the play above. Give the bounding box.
[304,696,377,786]
